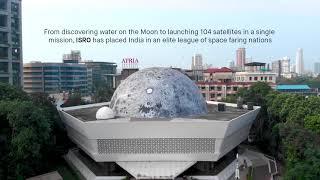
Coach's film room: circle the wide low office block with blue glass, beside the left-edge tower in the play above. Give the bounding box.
[23,62,91,95]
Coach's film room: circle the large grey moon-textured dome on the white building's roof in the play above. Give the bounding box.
[110,68,207,118]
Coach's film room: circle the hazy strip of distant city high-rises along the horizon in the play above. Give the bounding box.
[24,48,320,76]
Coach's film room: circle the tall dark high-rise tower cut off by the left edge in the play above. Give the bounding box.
[0,0,22,86]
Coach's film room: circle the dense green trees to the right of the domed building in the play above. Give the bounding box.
[234,81,320,177]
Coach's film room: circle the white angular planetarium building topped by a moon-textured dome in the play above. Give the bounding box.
[59,68,260,180]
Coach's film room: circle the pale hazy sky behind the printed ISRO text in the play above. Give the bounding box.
[22,0,320,69]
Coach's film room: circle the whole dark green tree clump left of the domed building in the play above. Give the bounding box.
[0,83,70,179]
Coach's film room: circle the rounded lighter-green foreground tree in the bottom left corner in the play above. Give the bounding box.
[0,100,52,179]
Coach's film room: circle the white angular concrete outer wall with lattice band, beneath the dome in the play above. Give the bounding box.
[60,102,260,162]
